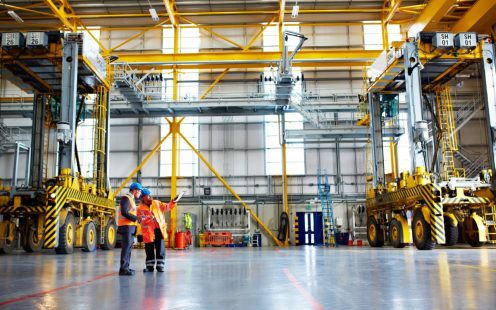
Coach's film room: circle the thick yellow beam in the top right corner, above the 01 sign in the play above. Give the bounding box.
[451,0,496,34]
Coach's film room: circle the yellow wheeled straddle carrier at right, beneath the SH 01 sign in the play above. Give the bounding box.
[367,33,496,250]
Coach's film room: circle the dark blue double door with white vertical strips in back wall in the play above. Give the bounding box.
[296,212,324,245]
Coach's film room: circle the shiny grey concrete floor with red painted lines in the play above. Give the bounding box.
[0,247,496,310]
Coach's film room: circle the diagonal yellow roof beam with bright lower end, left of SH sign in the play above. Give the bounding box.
[408,0,457,37]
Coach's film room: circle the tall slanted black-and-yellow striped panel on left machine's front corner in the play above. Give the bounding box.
[43,186,69,249]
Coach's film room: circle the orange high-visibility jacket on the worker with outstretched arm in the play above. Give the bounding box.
[137,200,176,243]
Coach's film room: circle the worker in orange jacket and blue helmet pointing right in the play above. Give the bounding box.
[137,188,182,272]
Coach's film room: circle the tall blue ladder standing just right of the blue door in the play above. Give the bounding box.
[317,170,336,247]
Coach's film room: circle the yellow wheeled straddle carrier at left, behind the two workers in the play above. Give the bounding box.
[0,33,116,254]
